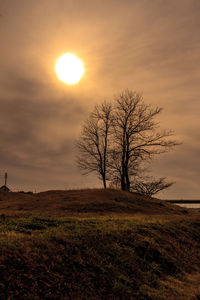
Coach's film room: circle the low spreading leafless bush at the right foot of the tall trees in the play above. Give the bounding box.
[132,178,174,197]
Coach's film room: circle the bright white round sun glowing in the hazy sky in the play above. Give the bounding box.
[55,53,85,84]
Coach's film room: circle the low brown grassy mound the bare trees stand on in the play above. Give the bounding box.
[0,189,186,216]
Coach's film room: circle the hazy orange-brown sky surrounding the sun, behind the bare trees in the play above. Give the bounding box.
[0,0,200,199]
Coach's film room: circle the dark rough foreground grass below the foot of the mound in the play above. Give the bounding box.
[0,216,200,300]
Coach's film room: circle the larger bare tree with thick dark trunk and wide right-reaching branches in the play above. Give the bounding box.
[110,90,178,191]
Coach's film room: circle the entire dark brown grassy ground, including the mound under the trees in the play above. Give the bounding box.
[0,189,200,300]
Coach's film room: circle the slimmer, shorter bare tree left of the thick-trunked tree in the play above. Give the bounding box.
[77,102,112,188]
